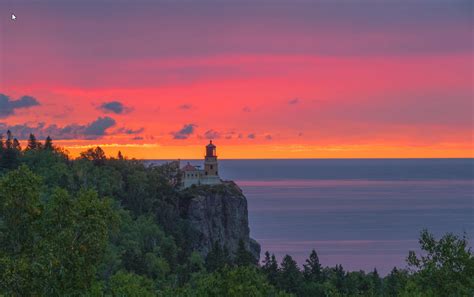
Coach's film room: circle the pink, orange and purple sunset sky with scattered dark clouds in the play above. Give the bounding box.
[0,0,474,159]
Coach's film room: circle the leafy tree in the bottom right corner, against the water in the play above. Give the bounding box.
[407,230,474,296]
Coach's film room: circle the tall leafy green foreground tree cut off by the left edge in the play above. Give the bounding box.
[0,166,43,296]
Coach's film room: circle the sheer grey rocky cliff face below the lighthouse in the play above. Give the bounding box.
[184,182,260,259]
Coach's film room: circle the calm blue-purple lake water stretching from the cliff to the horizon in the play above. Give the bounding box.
[151,159,474,274]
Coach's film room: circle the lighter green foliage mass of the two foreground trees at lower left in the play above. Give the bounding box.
[0,165,113,296]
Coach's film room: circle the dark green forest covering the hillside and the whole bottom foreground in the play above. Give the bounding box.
[0,131,474,297]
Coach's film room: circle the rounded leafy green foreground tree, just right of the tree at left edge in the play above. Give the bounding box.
[39,189,118,296]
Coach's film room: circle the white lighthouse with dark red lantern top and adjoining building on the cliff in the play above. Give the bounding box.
[181,140,222,188]
